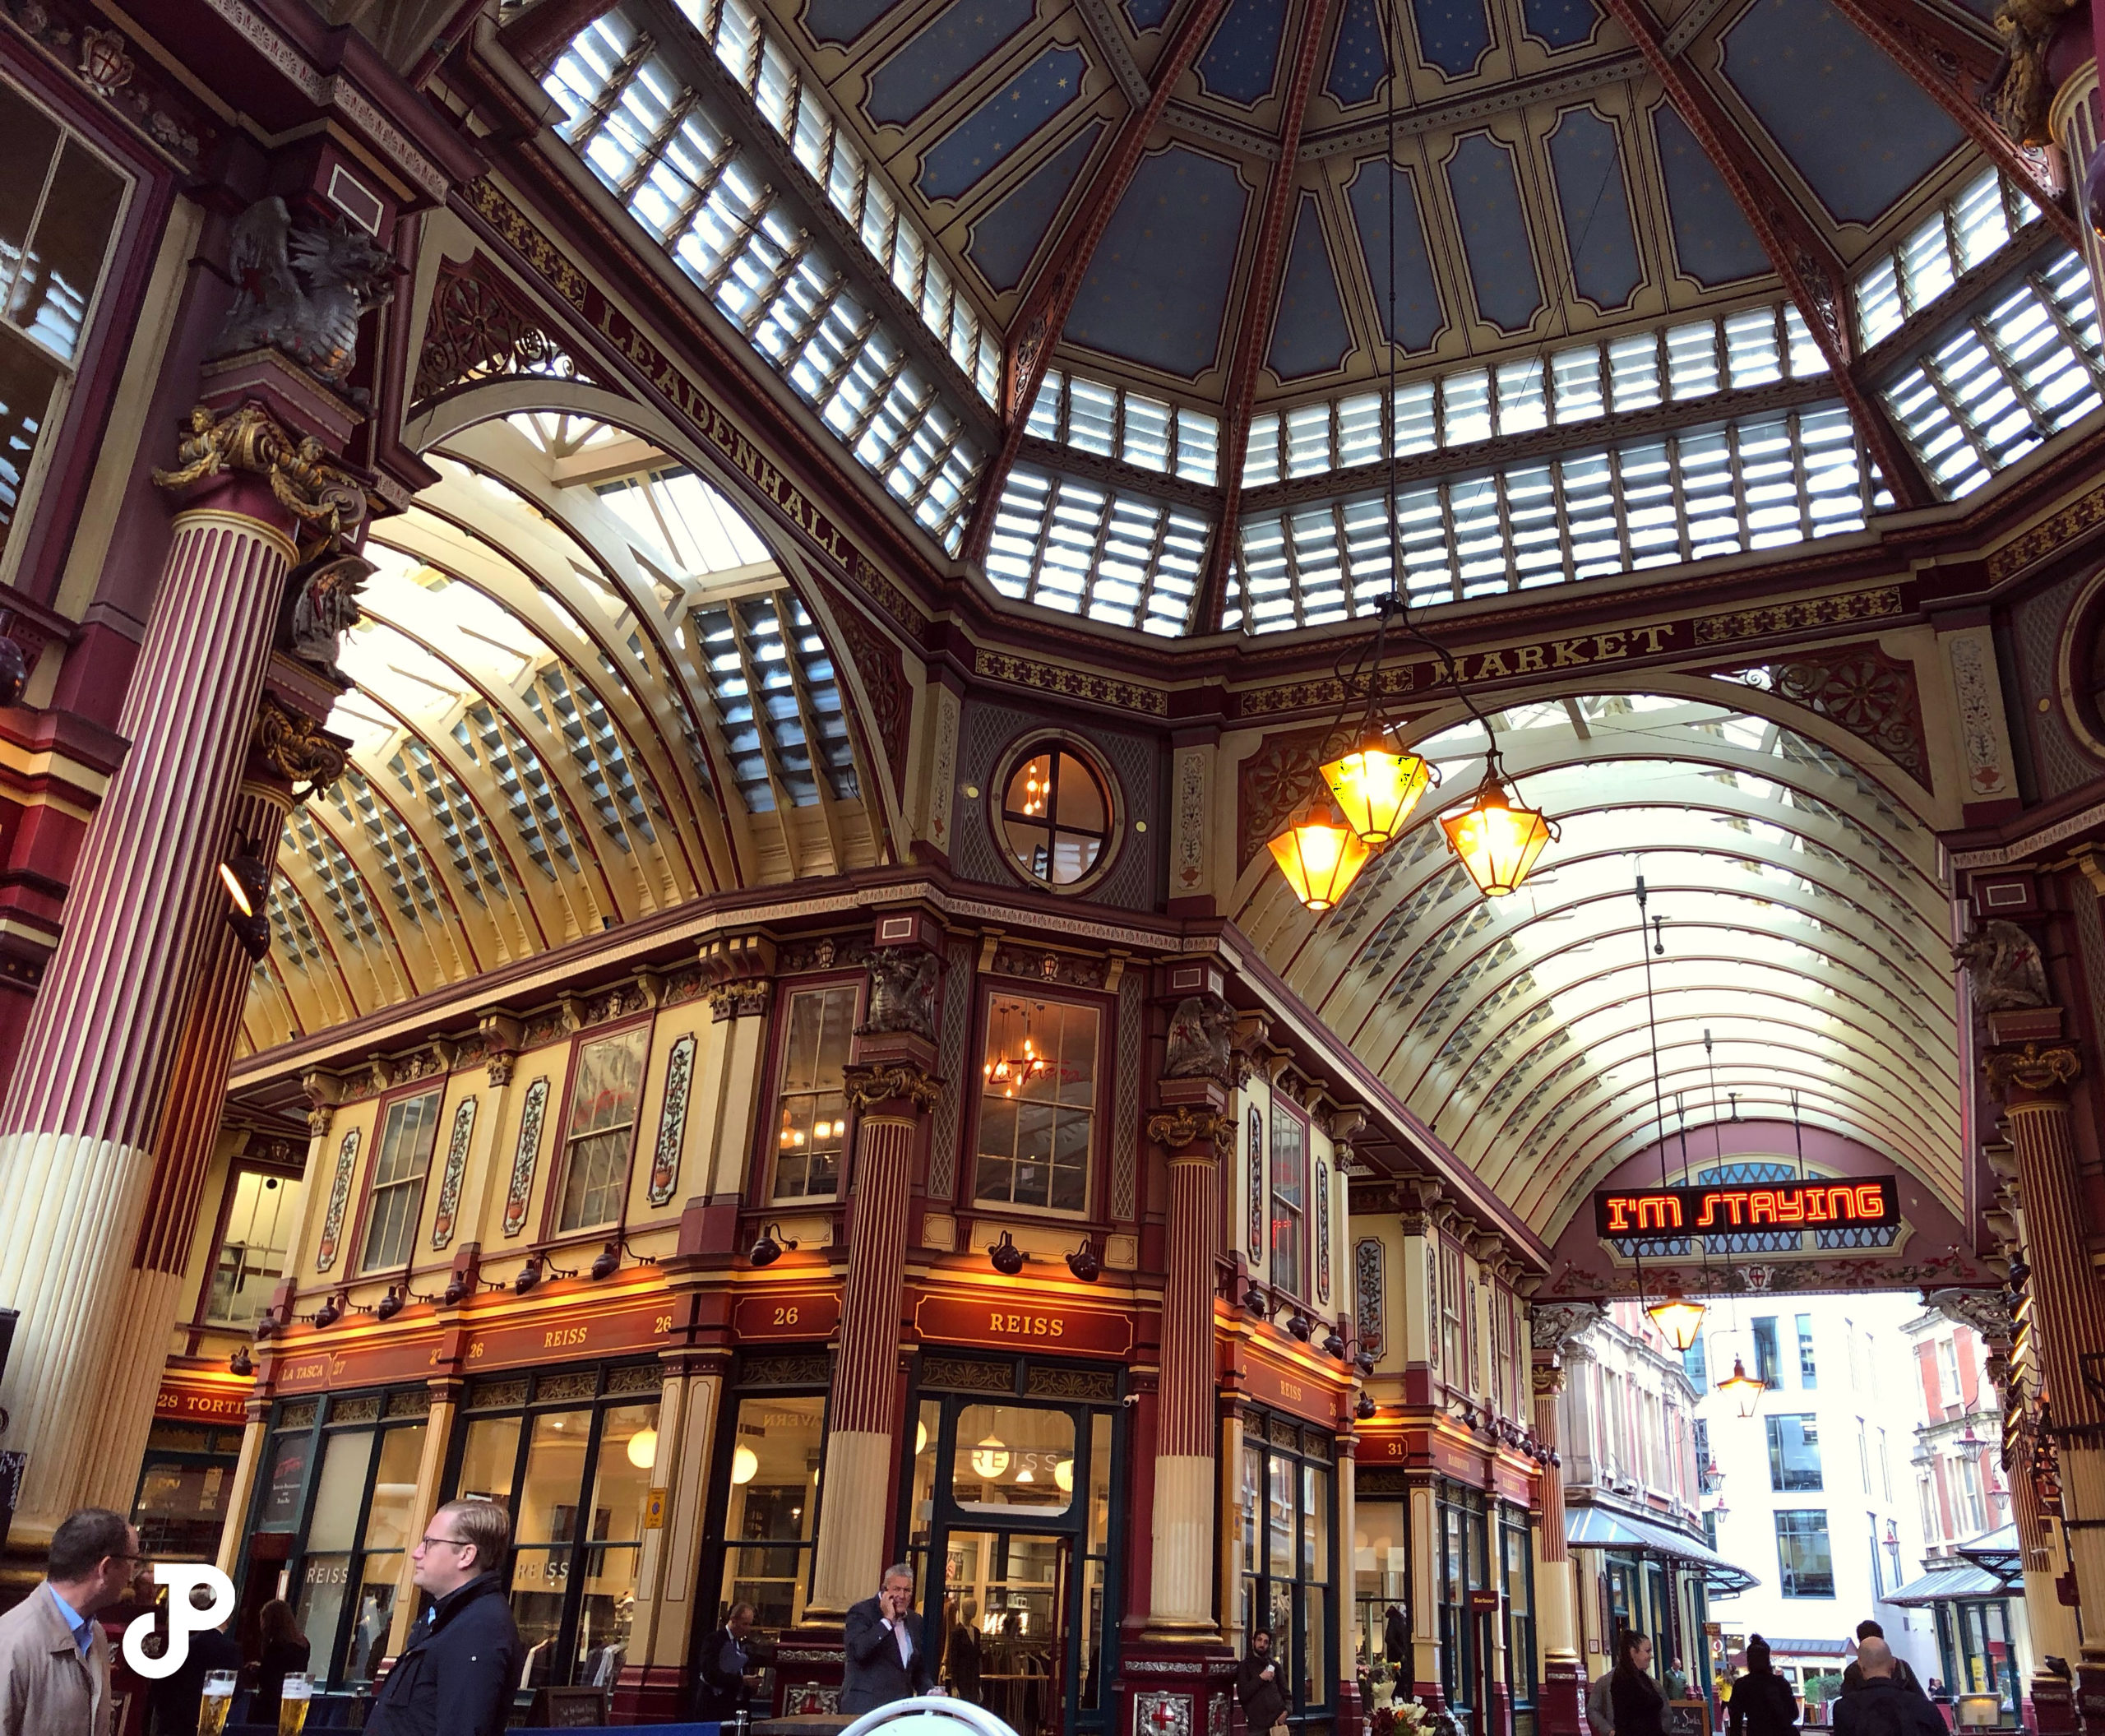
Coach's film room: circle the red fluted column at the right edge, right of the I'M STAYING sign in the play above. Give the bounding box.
[1985,1030,2105,1729]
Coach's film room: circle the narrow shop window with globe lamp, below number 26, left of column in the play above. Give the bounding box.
[711,1393,826,1635]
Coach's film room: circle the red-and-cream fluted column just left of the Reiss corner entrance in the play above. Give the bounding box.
[806,1044,941,1624]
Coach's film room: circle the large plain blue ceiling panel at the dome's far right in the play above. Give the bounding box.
[1724,0,1964,223]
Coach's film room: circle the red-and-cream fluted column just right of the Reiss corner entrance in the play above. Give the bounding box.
[1147,1081,1236,1639]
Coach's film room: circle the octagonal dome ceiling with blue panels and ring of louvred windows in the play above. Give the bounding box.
[522,0,2101,636]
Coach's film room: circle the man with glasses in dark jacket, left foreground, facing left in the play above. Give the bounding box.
[366,1500,520,1736]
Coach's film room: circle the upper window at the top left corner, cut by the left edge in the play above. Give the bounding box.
[0,84,127,551]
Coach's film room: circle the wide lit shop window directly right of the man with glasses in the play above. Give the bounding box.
[452,1366,665,1687]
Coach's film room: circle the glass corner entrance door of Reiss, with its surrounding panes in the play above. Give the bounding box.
[911,1395,1116,1736]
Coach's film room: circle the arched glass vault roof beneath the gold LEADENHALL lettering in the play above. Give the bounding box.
[244,414,880,1048]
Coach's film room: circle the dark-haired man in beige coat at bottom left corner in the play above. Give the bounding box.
[0,1507,139,1736]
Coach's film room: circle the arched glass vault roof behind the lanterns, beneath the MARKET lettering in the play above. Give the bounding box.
[1236,682,1959,1224]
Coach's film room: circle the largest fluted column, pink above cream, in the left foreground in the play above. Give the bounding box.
[0,474,294,1538]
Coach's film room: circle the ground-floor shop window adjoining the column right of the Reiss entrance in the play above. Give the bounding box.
[1240,1414,1337,1713]
